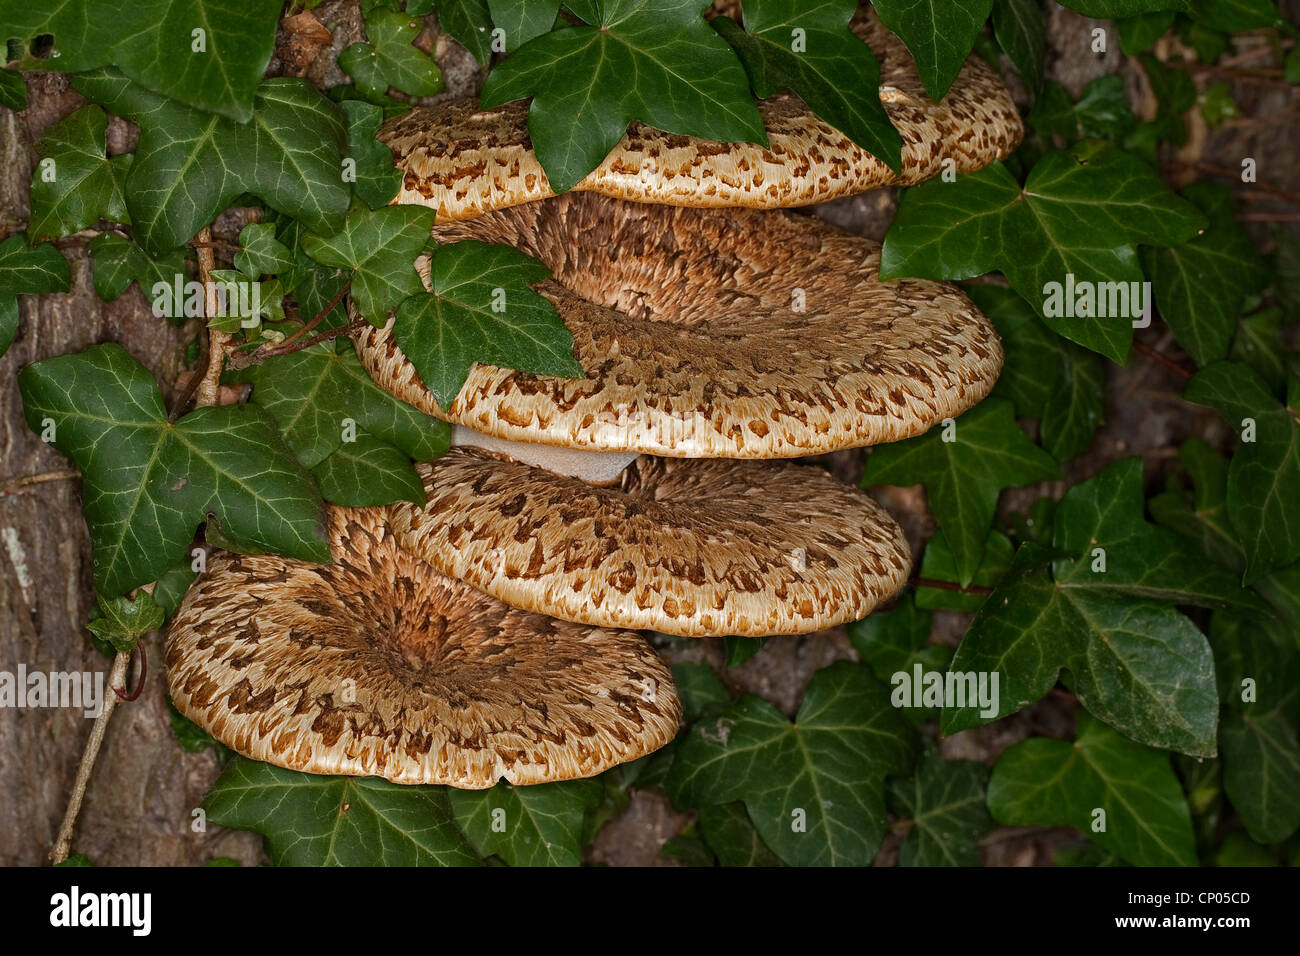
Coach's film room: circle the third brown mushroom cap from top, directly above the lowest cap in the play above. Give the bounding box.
[393,449,911,637]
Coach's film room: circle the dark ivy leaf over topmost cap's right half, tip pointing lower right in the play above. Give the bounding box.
[714,0,904,172]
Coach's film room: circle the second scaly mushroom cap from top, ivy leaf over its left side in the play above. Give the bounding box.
[354,194,1002,458]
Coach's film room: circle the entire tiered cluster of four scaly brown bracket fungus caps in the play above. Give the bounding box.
[168,5,1023,788]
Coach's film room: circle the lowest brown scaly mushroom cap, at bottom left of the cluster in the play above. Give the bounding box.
[166,509,681,790]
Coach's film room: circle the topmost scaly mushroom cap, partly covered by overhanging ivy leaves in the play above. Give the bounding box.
[378,8,1024,222]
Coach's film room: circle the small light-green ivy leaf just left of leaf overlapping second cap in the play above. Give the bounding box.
[303,203,434,325]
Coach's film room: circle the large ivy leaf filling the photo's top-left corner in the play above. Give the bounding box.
[0,0,282,122]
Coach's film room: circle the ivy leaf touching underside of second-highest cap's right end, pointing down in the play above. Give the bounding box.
[862,398,1060,585]
